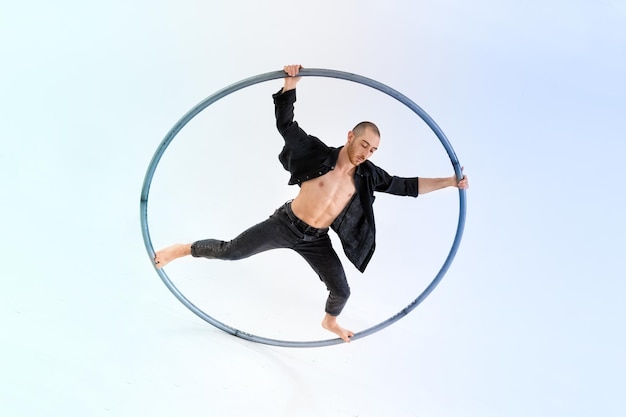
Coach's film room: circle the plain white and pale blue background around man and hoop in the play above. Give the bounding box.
[0,0,626,417]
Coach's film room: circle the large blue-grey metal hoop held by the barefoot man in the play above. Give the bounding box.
[140,69,466,347]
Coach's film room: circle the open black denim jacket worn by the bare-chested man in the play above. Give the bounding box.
[272,90,418,272]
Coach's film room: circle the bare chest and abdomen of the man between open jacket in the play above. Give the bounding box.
[291,170,355,229]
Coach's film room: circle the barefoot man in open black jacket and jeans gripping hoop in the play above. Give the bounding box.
[155,65,469,342]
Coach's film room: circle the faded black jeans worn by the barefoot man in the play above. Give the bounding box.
[191,201,350,316]
